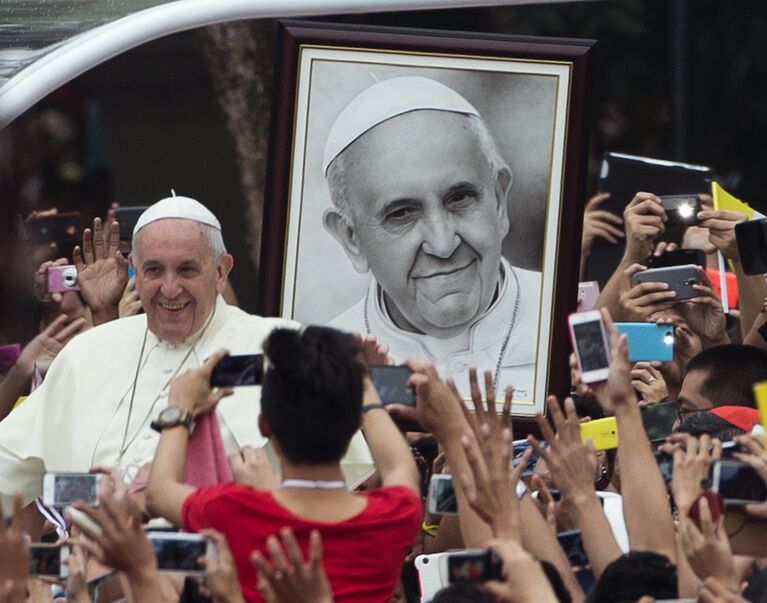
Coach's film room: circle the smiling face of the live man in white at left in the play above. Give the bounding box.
[131,219,232,343]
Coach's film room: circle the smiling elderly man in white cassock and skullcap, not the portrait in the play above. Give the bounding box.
[0,197,372,510]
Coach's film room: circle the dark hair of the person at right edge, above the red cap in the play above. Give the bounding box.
[685,344,767,408]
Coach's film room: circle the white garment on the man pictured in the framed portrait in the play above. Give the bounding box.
[330,258,541,402]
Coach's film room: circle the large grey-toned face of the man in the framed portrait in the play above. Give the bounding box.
[336,111,510,337]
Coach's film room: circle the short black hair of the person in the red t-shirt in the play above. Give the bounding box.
[261,326,365,464]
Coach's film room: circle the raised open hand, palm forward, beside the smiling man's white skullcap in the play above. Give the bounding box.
[72,218,128,325]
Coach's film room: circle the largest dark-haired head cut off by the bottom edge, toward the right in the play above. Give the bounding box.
[586,551,678,603]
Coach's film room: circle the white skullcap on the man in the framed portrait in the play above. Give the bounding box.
[322,75,479,174]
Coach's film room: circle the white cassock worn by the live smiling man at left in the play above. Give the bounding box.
[0,296,373,513]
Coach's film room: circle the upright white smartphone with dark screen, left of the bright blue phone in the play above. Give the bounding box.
[567,310,610,383]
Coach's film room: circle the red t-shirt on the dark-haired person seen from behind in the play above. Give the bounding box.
[181,484,421,603]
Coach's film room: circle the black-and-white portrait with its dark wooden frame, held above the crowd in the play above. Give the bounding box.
[259,21,593,417]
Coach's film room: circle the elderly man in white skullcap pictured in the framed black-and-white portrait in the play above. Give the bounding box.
[323,76,540,400]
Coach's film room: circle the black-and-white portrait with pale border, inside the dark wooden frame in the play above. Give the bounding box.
[281,46,569,415]
